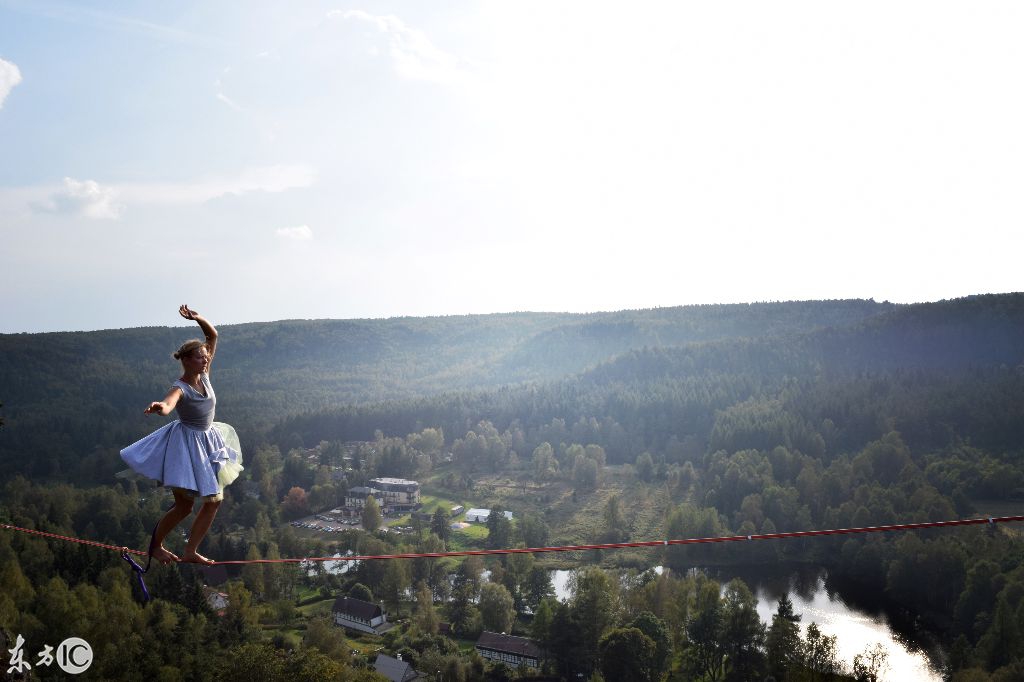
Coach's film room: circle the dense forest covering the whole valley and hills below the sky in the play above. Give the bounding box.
[0,294,1024,681]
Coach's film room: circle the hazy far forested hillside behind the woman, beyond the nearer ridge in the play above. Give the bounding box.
[0,301,898,483]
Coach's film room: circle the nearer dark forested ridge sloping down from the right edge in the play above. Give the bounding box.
[271,295,1024,463]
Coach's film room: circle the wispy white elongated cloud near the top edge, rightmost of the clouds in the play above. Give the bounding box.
[327,9,468,85]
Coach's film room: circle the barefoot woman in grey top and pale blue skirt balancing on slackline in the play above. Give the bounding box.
[121,305,242,564]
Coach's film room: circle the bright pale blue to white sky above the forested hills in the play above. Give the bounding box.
[0,0,1024,333]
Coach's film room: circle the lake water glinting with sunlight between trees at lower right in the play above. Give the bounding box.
[551,567,942,682]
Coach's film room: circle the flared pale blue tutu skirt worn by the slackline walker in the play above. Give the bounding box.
[121,421,243,498]
